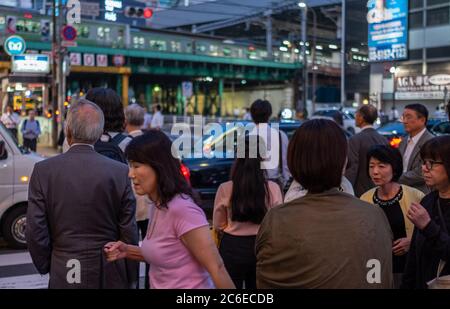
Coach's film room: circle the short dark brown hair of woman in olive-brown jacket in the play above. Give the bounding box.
[288,119,347,193]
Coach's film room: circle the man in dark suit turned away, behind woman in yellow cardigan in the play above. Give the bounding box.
[345,105,387,197]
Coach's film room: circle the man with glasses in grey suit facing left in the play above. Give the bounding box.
[399,104,434,194]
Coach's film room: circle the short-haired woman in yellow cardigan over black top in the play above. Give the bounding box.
[361,145,424,287]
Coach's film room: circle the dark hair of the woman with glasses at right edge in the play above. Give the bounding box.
[420,135,450,179]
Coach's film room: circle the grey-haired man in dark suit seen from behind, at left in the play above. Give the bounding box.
[26,100,138,288]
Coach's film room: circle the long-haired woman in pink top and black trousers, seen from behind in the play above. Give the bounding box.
[213,135,283,289]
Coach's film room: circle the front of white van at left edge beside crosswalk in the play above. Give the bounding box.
[0,123,44,249]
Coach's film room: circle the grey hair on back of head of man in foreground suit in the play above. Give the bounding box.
[66,99,105,144]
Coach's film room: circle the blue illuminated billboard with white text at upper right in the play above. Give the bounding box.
[367,0,408,62]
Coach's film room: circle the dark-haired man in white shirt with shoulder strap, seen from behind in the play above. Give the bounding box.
[250,100,291,190]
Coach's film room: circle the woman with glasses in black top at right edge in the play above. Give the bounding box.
[402,136,450,289]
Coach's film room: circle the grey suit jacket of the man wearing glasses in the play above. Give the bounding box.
[398,130,434,194]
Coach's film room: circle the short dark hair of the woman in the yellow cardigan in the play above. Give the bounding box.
[366,145,403,182]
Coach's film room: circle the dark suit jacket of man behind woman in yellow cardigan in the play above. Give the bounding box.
[345,128,388,197]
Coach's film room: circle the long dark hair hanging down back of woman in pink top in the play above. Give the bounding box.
[231,135,270,224]
